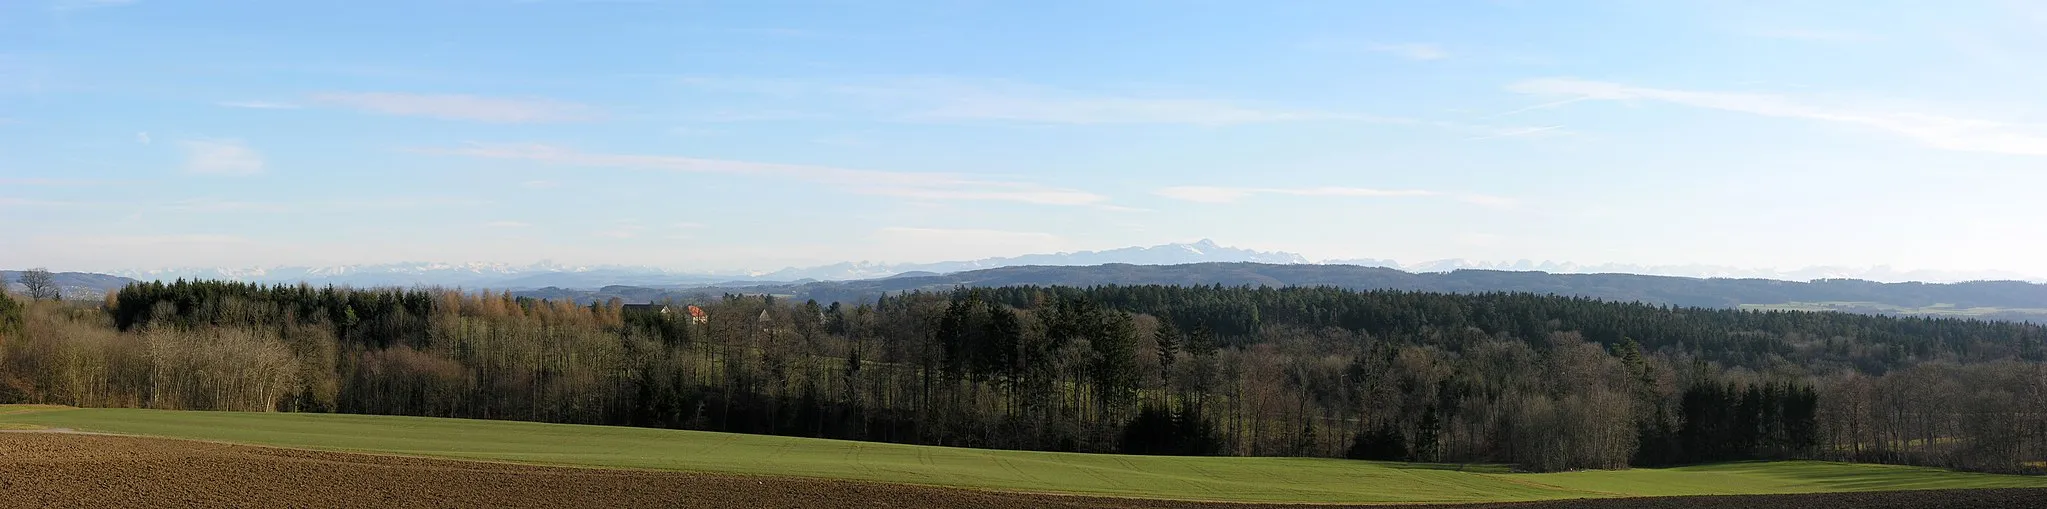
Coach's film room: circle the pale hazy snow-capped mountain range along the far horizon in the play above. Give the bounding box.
[88,239,2041,290]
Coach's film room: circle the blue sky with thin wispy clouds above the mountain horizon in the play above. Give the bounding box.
[0,0,2047,274]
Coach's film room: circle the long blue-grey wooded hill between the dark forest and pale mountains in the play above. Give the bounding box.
[522,264,2047,321]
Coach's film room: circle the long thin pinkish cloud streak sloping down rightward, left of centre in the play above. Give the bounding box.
[420,143,1107,204]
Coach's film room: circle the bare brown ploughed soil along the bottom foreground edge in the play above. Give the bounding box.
[0,433,2047,509]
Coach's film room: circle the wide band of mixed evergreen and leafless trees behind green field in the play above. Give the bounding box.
[0,282,2047,472]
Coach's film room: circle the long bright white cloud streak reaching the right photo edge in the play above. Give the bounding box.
[1509,78,2047,155]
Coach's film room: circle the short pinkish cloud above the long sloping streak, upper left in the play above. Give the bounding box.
[311,92,600,123]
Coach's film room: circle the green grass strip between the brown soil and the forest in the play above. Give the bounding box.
[0,407,2047,503]
